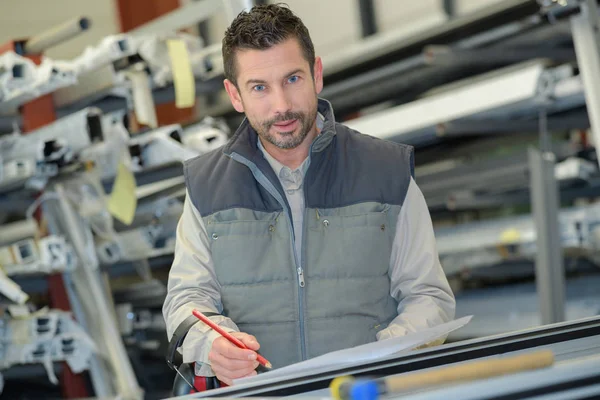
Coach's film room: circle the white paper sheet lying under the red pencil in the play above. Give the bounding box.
[233,315,473,385]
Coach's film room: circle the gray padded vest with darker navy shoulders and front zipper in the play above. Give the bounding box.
[184,99,414,367]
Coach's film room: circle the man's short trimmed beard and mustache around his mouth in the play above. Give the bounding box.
[252,107,317,149]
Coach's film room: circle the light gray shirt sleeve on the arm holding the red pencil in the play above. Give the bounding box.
[163,193,239,376]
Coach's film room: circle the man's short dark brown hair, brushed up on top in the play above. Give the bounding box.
[222,3,315,86]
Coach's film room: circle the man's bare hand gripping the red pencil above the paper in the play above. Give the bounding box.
[208,332,260,385]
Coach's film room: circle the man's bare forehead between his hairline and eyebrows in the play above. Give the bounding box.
[236,39,309,84]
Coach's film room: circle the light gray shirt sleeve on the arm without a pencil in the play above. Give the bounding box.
[377,178,456,342]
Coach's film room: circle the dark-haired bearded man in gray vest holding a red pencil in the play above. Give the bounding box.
[163,5,455,384]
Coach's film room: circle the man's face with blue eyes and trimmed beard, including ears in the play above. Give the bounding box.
[225,39,323,149]
